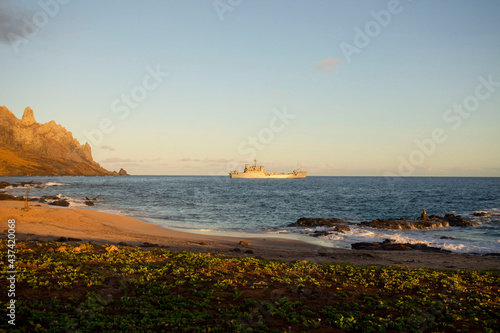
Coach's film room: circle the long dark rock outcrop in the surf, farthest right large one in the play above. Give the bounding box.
[360,214,477,229]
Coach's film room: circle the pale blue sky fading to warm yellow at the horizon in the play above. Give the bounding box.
[0,0,500,177]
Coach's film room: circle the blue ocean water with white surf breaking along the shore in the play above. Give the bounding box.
[0,176,500,254]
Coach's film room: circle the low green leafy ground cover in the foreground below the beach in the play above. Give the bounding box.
[0,241,500,333]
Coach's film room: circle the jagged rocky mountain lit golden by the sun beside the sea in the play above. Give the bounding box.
[0,106,126,176]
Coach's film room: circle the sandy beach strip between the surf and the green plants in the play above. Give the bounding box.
[0,201,500,270]
